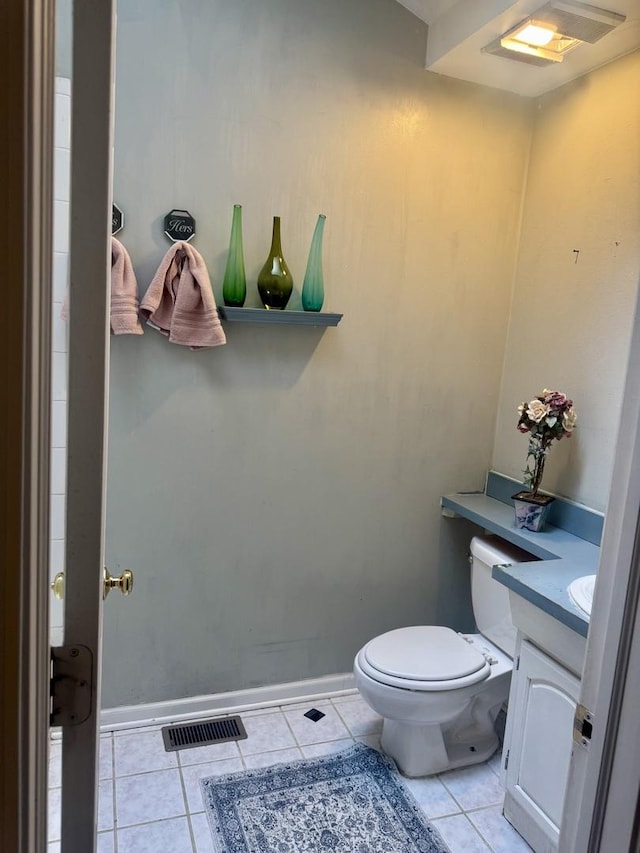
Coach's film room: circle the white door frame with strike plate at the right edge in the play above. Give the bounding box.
[560,292,640,853]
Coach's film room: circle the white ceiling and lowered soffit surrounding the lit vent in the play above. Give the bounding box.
[398,0,640,97]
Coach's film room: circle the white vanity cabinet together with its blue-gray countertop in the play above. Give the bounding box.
[441,480,603,853]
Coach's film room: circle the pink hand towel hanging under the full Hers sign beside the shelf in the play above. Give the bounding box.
[140,241,227,349]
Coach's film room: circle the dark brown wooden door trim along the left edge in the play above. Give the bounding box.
[0,0,54,853]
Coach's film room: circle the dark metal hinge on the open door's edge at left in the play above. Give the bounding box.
[49,644,93,726]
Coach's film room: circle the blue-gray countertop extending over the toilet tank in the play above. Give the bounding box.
[441,475,600,637]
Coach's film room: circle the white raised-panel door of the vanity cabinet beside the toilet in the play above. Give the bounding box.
[504,635,580,853]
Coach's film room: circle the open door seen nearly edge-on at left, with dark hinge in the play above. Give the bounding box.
[52,0,119,853]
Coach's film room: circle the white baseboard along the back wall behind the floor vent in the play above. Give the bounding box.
[100,672,356,731]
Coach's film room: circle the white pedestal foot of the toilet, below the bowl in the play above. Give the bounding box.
[380,720,500,778]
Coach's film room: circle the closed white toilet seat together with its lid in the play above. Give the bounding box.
[357,625,491,692]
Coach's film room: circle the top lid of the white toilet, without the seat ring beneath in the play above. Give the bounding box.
[363,625,488,682]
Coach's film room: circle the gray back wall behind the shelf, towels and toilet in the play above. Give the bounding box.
[104,0,531,707]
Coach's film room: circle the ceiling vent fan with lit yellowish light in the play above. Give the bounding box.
[482,0,626,65]
